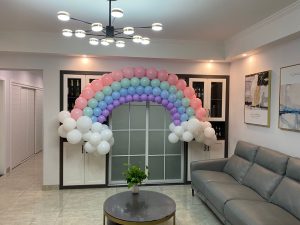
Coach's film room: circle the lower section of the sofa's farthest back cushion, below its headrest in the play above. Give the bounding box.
[224,155,252,183]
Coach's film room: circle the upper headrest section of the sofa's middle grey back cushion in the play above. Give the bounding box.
[255,147,289,175]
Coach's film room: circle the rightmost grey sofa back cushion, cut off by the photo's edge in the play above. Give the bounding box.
[271,158,300,219]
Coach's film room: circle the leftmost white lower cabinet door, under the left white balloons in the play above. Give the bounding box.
[63,142,84,186]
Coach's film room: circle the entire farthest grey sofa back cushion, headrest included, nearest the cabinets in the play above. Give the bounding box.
[224,141,258,183]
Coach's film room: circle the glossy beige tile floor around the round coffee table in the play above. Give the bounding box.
[0,153,221,225]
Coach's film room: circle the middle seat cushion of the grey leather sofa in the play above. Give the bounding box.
[205,182,264,214]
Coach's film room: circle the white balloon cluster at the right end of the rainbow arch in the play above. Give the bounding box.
[168,118,217,146]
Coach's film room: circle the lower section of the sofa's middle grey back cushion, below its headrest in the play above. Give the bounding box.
[243,163,282,199]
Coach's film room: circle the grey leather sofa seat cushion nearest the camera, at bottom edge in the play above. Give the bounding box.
[224,200,300,225]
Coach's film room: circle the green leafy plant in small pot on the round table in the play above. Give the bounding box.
[123,165,148,194]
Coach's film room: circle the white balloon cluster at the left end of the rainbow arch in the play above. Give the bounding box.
[58,111,114,155]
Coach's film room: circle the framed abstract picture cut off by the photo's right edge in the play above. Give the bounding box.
[278,64,300,132]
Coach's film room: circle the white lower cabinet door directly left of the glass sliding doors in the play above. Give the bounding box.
[84,153,106,184]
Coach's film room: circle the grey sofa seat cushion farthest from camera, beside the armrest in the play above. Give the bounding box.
[191,170,237,193]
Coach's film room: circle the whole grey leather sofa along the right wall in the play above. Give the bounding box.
[190,141,300,225]
